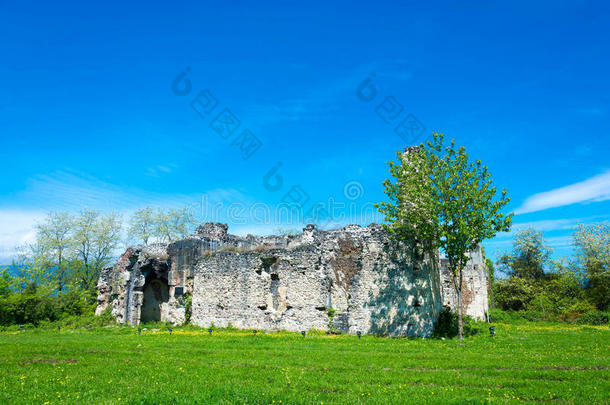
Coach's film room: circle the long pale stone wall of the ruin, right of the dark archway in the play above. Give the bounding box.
[192,225,442,336]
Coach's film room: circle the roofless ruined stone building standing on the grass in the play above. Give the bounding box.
[97,223,488,336]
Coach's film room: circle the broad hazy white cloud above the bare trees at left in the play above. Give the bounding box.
[0,172,252,265]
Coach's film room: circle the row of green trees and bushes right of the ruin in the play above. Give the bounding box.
[487,223,610,323]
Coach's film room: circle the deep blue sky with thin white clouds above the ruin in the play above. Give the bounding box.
[0,1,610,262]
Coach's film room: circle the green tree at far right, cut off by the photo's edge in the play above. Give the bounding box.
[574,222,610,311]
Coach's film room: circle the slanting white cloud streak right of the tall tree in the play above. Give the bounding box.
[515,170,610,214]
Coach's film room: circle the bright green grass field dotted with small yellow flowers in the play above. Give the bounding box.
[0,323,610,404]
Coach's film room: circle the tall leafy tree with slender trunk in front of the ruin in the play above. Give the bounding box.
[377,133,512,339]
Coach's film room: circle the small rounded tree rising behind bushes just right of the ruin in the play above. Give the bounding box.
[498,228,553,280]
